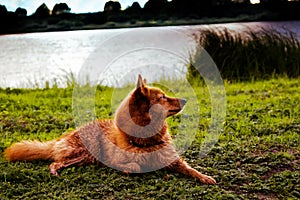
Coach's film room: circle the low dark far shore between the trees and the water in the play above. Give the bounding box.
[0,13,298,35]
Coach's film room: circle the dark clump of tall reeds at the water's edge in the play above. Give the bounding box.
[188,29,300,80]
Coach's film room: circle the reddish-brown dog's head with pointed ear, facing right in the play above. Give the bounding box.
[115,75,186,136]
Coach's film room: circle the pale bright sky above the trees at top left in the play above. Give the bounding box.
[0,0,148,15]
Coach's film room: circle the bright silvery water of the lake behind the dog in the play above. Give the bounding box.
[0,21,300,88]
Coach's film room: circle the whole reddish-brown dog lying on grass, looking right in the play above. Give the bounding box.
[4,75,216,184]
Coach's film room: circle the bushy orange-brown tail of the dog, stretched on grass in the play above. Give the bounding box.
[4,141,54,161]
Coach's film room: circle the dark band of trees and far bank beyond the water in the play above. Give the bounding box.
[0,0,300,34]
